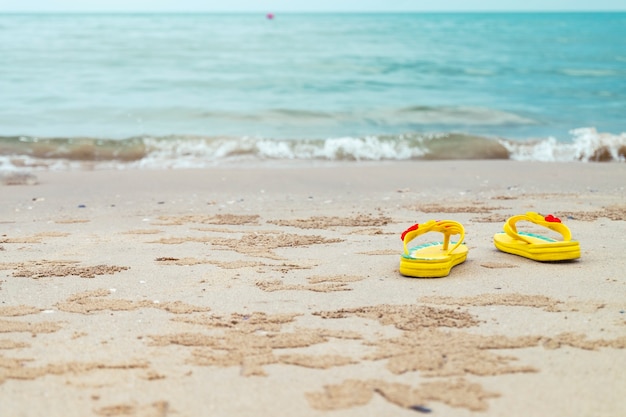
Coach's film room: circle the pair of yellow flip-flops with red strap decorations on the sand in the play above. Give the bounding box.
[400,212,580,278]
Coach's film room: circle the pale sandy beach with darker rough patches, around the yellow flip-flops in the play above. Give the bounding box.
[0,161,626,417]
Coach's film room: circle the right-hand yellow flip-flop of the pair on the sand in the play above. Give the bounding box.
[493,212,580,262]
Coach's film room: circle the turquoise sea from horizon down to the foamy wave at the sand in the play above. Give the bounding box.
[0,13,626,170]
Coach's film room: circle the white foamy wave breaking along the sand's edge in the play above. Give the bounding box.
[0,128,626,170]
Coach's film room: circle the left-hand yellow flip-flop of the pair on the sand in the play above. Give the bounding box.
[400,220,467,278]
